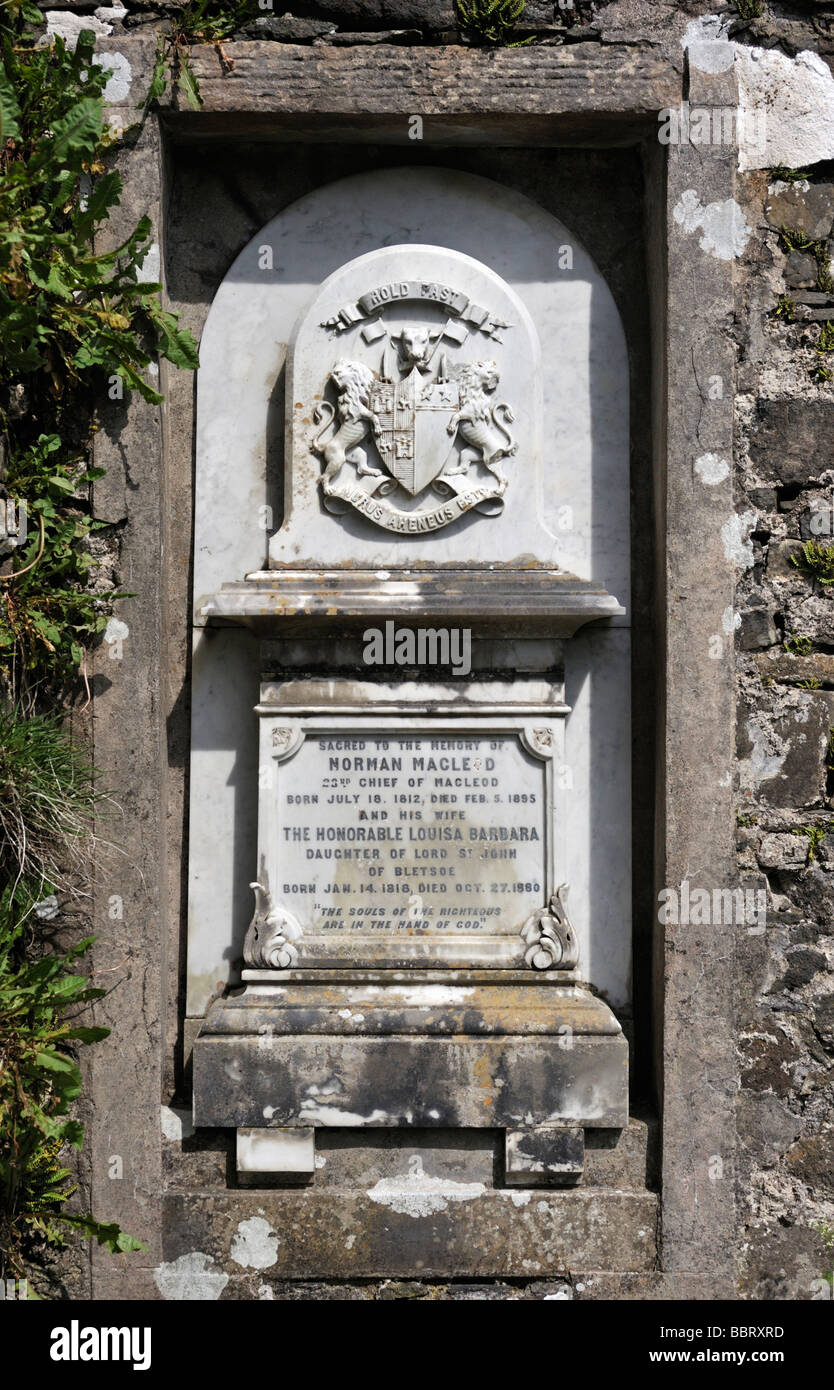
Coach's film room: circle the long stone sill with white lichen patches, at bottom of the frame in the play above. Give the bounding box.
[160,1175,657,1300]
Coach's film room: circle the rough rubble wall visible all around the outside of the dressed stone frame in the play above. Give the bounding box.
[27,0,834,1300]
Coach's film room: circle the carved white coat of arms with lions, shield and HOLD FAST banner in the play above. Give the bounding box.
[310,284,518,532]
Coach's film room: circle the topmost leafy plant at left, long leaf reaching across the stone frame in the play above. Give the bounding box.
[0,31,197,402]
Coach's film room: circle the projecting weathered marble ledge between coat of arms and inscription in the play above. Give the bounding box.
[196,566,626,637]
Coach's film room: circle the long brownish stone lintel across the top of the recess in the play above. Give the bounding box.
[163,42,682,126]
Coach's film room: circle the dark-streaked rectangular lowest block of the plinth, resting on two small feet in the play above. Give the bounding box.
[195,1036,628,1129]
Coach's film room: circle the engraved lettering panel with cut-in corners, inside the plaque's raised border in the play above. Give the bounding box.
[272,731,548,937]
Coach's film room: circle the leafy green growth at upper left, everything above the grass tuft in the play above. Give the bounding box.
[0,16,197,701]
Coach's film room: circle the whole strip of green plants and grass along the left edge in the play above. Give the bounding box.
[0,0,197,1276]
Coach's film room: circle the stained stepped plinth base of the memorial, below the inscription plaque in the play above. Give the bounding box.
[193,972,628,1184]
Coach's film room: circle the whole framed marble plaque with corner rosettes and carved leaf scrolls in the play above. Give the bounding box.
[246,705,572,967]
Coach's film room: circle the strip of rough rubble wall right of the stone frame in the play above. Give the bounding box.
[735,164,834,1298]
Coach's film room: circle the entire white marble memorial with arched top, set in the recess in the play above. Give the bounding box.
[183,159,642,1259]
